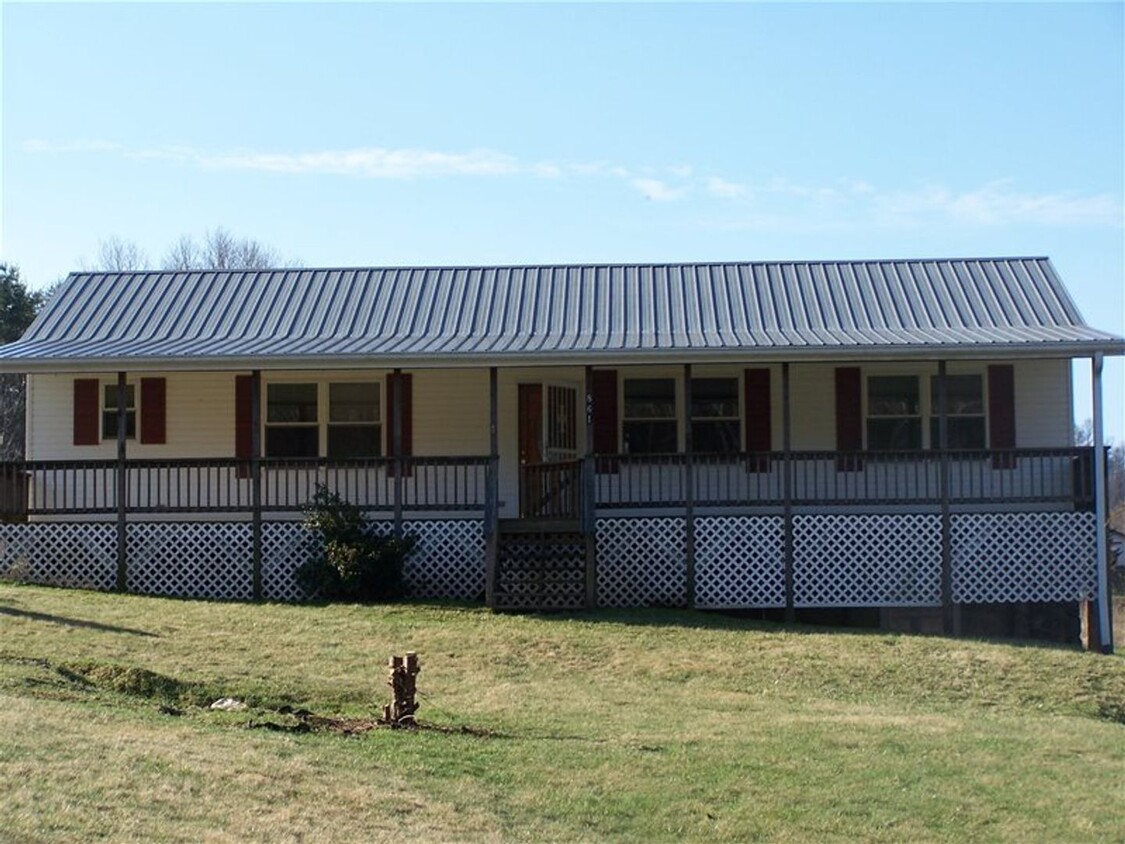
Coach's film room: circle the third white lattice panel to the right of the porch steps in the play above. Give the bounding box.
[793,513,942,607]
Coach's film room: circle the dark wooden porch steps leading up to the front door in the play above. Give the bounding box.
[495,519,586,611]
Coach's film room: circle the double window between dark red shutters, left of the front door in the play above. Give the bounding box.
[266,381,383,458]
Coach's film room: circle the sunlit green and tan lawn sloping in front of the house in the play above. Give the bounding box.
[0,585,1125,842]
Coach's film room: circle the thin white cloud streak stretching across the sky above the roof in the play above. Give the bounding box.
[23,138,1125,231]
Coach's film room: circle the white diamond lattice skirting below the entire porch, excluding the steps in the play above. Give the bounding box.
[0,513,1097,609]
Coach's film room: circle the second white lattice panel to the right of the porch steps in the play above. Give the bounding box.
[695,515,785,609]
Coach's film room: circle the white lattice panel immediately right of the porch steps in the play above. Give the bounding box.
[596,517,687,607]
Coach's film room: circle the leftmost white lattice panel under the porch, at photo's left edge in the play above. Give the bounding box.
[0,522,117,590]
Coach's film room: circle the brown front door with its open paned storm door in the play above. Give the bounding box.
[519,384,578,518]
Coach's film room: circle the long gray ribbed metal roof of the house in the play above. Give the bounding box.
[0,258,1125,371]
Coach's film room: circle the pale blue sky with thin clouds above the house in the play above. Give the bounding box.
[0,2,1125,439]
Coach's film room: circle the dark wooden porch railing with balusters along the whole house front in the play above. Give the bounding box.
[0,448,1094,519]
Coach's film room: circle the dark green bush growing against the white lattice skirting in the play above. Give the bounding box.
[296,484,416,601]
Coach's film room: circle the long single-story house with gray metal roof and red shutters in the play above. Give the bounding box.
[0,258,1125,648]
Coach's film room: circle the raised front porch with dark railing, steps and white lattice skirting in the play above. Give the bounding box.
[0,448,1097,631]
